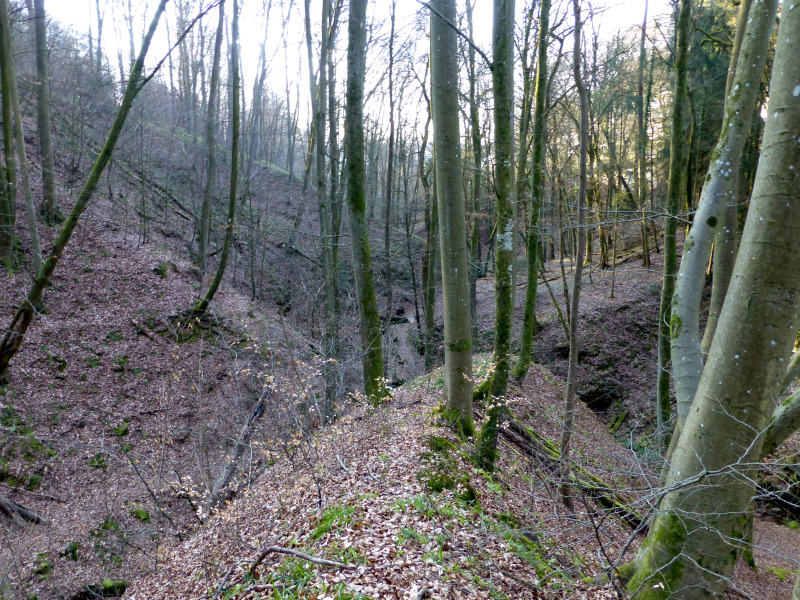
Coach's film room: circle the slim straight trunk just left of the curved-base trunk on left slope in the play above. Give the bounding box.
[197,0,225,273]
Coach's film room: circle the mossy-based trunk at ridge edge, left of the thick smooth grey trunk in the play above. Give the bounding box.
[344,0,386,403]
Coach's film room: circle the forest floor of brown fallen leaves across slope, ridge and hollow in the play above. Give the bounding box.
[0,191,800,600]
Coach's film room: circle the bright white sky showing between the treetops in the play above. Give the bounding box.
[46,0,670,118]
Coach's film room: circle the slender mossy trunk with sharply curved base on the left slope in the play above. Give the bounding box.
[192,0,241,316]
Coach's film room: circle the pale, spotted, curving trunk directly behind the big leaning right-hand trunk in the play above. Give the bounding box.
[670,0,778,423]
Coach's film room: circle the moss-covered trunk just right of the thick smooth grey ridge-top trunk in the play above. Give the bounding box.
[478,0,516,471]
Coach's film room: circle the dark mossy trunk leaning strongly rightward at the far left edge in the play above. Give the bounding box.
[0,0,168,380]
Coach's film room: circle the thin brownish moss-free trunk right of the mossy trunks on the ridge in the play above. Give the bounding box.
[561,0,589,506]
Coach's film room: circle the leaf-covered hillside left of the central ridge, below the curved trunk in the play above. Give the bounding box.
[0,188,332,598]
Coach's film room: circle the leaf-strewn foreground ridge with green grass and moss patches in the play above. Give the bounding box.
[126,360,641,599]
